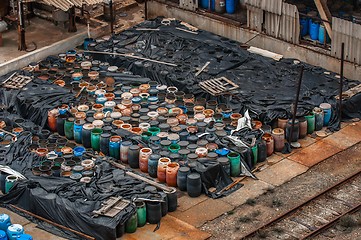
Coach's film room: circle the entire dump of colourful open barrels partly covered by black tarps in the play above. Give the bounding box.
[0,18,360,239]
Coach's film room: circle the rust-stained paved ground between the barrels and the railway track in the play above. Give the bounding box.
[0,122,361,240]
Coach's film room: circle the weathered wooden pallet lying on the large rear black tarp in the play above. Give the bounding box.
[199,77,239,96]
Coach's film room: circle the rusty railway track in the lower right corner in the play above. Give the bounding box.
[241,171,361,239]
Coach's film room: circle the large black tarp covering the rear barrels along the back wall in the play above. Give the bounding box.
[90,18,361,130]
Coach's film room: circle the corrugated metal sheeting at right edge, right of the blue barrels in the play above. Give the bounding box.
[331,17,361,64]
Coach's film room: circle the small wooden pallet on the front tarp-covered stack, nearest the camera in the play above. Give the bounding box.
[93,197,130,217]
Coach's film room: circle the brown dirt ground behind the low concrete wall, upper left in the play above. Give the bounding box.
[0,17,86,64]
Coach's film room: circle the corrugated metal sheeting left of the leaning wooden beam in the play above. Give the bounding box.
[245,0,300,44]
